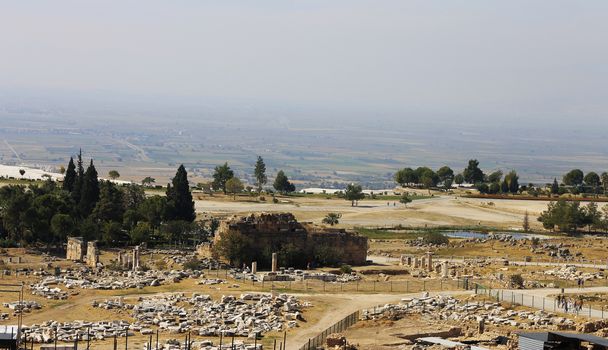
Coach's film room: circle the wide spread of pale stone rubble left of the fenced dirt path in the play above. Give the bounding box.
[93,293,310,337]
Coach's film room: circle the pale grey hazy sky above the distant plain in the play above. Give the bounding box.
[0,0,608,122]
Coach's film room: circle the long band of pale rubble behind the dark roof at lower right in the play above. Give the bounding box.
[362,296,576,330]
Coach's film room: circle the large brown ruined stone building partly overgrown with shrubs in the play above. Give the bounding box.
[214,213,368,268]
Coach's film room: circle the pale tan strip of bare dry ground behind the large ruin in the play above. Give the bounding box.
[195,194,604,230]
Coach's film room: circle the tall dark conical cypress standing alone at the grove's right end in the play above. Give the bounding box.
[166,165,196,222]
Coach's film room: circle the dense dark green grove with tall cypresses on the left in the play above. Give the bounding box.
[0,152,203,247]
